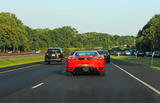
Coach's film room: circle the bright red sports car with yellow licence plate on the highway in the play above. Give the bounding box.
[67,51,105,76]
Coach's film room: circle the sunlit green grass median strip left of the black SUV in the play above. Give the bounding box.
[0,56,44,68]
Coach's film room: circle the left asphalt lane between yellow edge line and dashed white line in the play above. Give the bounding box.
[0,63,65,99]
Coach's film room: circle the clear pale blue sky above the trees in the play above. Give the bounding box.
[0,0,160,35]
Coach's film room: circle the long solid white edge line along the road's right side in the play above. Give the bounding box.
[112,63,160,95]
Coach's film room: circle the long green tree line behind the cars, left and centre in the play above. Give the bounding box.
[0,12,135,52]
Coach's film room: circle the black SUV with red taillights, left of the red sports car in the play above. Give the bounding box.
[45,48,65,64]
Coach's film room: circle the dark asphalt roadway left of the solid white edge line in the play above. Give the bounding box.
[0,60,160,103]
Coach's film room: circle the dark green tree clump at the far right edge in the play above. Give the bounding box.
[136,15,160,51]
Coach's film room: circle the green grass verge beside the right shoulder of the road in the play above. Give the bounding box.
[111,56,160,70]
